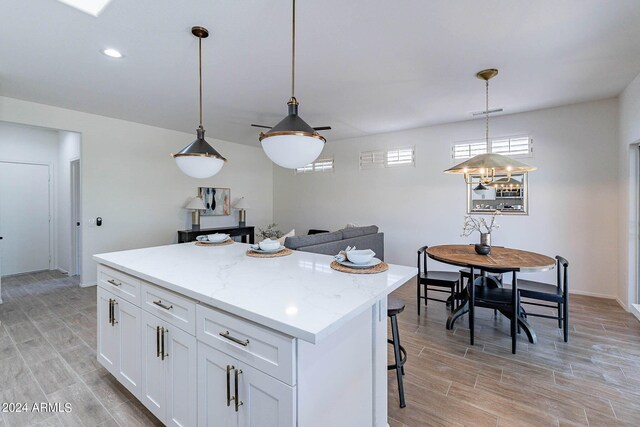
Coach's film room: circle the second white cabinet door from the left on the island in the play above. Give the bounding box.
[114,298,142,396]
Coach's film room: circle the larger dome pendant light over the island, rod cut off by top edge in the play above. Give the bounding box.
[255,0,331,169]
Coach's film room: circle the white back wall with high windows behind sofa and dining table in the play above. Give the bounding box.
[274,99,618,297]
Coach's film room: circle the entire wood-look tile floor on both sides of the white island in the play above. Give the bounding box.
[0,272,640,427]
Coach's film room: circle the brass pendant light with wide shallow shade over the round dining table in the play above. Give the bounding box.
[444,68,537,184]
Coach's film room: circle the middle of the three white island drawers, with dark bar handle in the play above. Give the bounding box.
[142,283,196,335]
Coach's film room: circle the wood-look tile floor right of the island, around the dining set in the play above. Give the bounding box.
[388,281,640,427]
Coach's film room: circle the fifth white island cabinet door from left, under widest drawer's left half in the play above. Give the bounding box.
[198,342,238,427]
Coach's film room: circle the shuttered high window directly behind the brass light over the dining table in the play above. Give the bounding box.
[451,136,533,162]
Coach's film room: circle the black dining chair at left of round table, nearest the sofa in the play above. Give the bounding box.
[417,246,460,316]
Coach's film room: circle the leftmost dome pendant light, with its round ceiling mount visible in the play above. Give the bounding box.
[172,27,227,178]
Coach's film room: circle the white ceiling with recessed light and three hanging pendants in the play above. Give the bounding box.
[0,0,640,145]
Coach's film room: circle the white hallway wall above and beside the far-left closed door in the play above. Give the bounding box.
[0,121,58,276]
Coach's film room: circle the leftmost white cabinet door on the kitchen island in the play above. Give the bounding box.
[97,287,120,377]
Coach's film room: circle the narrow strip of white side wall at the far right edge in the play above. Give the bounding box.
[618,71,640,309]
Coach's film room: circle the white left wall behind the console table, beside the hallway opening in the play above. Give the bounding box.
[0,97,273,284]
